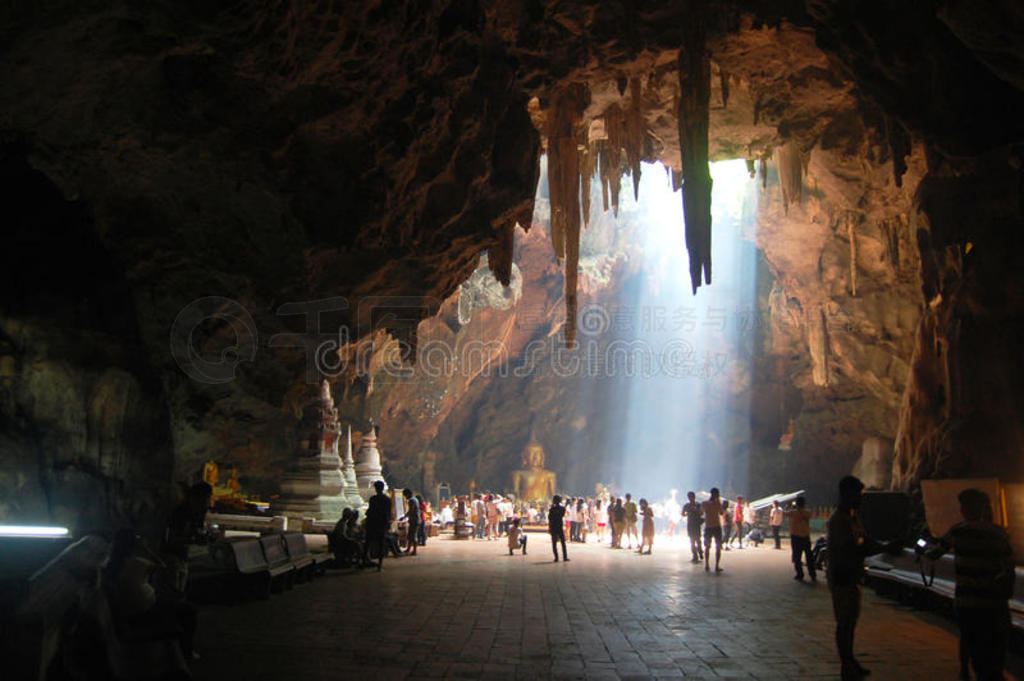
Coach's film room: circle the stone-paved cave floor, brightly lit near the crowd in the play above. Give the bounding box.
[194,535,1020,681]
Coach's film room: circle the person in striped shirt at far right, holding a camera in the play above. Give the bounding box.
[928,490,1015,681]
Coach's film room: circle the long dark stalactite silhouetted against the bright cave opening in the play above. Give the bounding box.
[678,0,712,293]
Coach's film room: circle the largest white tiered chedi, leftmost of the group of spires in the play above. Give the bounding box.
[271,381,349,521]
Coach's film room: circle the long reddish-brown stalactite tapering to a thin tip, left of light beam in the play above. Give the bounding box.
[547,84,589,346]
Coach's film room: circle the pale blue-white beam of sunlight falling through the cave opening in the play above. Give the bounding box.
[585,160,758,501]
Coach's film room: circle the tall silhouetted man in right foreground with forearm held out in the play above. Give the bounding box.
[827,475,891,681]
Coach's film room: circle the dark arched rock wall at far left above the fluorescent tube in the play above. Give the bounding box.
[0,143,174,531]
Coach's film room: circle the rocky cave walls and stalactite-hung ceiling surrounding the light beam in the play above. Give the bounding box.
[0,0,1024,548]
